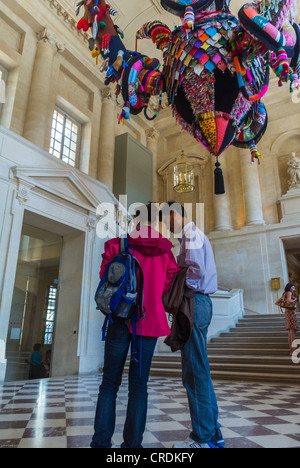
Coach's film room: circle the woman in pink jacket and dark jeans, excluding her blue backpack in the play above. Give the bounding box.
[91,205,179,448]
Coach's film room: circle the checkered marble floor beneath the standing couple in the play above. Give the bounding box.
[0,376,300,449]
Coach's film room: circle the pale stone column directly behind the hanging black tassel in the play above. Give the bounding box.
[211,156,233,231]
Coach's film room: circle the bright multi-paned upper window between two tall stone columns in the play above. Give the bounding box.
[50,109,80,167]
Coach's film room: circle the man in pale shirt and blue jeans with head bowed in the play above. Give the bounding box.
[162,202,225,449]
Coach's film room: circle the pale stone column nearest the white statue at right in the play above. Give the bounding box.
[240,150,266,226]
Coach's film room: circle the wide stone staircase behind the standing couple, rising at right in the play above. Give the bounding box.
[139,314,300,385]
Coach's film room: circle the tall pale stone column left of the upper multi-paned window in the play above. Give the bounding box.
[23,28,64,148]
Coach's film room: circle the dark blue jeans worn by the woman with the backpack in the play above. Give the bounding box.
[91,321,157,448]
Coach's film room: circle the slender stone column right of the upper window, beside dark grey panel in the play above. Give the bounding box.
[97,88,116,191]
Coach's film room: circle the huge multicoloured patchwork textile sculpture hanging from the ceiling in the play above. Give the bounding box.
[76,0,300,194]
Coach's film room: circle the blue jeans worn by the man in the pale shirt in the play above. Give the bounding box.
[181,294,220,443]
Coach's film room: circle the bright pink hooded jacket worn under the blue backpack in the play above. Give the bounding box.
[100,226,179,337]
